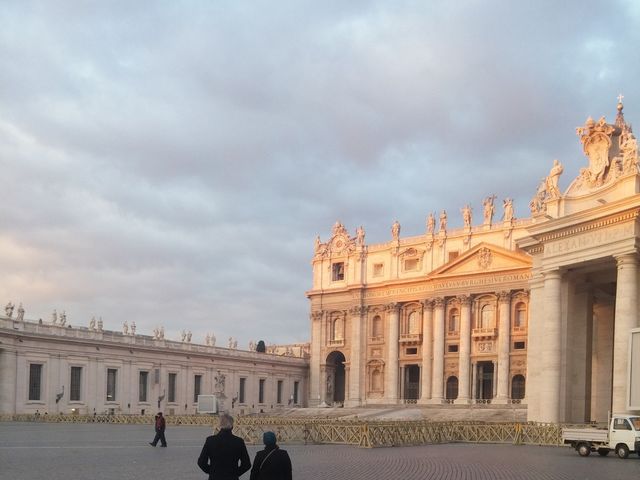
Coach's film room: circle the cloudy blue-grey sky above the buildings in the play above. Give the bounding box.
[0,0,640,347]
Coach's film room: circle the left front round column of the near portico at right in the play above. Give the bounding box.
[540,269,562,423]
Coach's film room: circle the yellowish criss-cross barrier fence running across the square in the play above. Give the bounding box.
[0,415,562,448]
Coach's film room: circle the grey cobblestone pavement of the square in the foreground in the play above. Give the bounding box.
[0,423,640,480]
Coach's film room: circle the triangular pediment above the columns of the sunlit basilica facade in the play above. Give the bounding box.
[430,243,531,277]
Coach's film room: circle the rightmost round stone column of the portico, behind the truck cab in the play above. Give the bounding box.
[611,253,638,413]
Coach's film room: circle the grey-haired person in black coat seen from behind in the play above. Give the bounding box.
[198,413,251,480]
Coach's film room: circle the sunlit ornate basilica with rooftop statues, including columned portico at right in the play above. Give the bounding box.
[307,99,640,422]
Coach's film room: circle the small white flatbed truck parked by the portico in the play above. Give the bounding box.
[562,414,640,458]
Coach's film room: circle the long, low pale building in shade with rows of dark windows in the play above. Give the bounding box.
[0,316,308,415]
